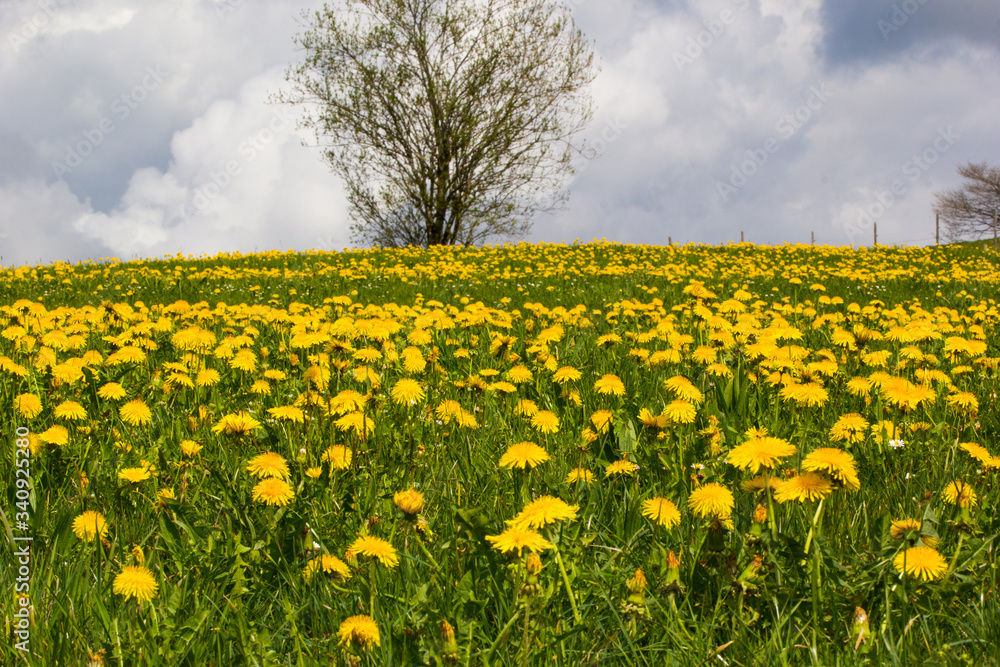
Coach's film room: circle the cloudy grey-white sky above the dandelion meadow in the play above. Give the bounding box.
[0,0,1000,267]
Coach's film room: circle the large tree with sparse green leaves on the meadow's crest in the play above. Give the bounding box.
[276,0,596,247]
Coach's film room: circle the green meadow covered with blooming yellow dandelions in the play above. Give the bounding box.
[0,242,1000,667]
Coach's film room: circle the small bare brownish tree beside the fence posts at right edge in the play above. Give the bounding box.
[934,162,1000,240]
